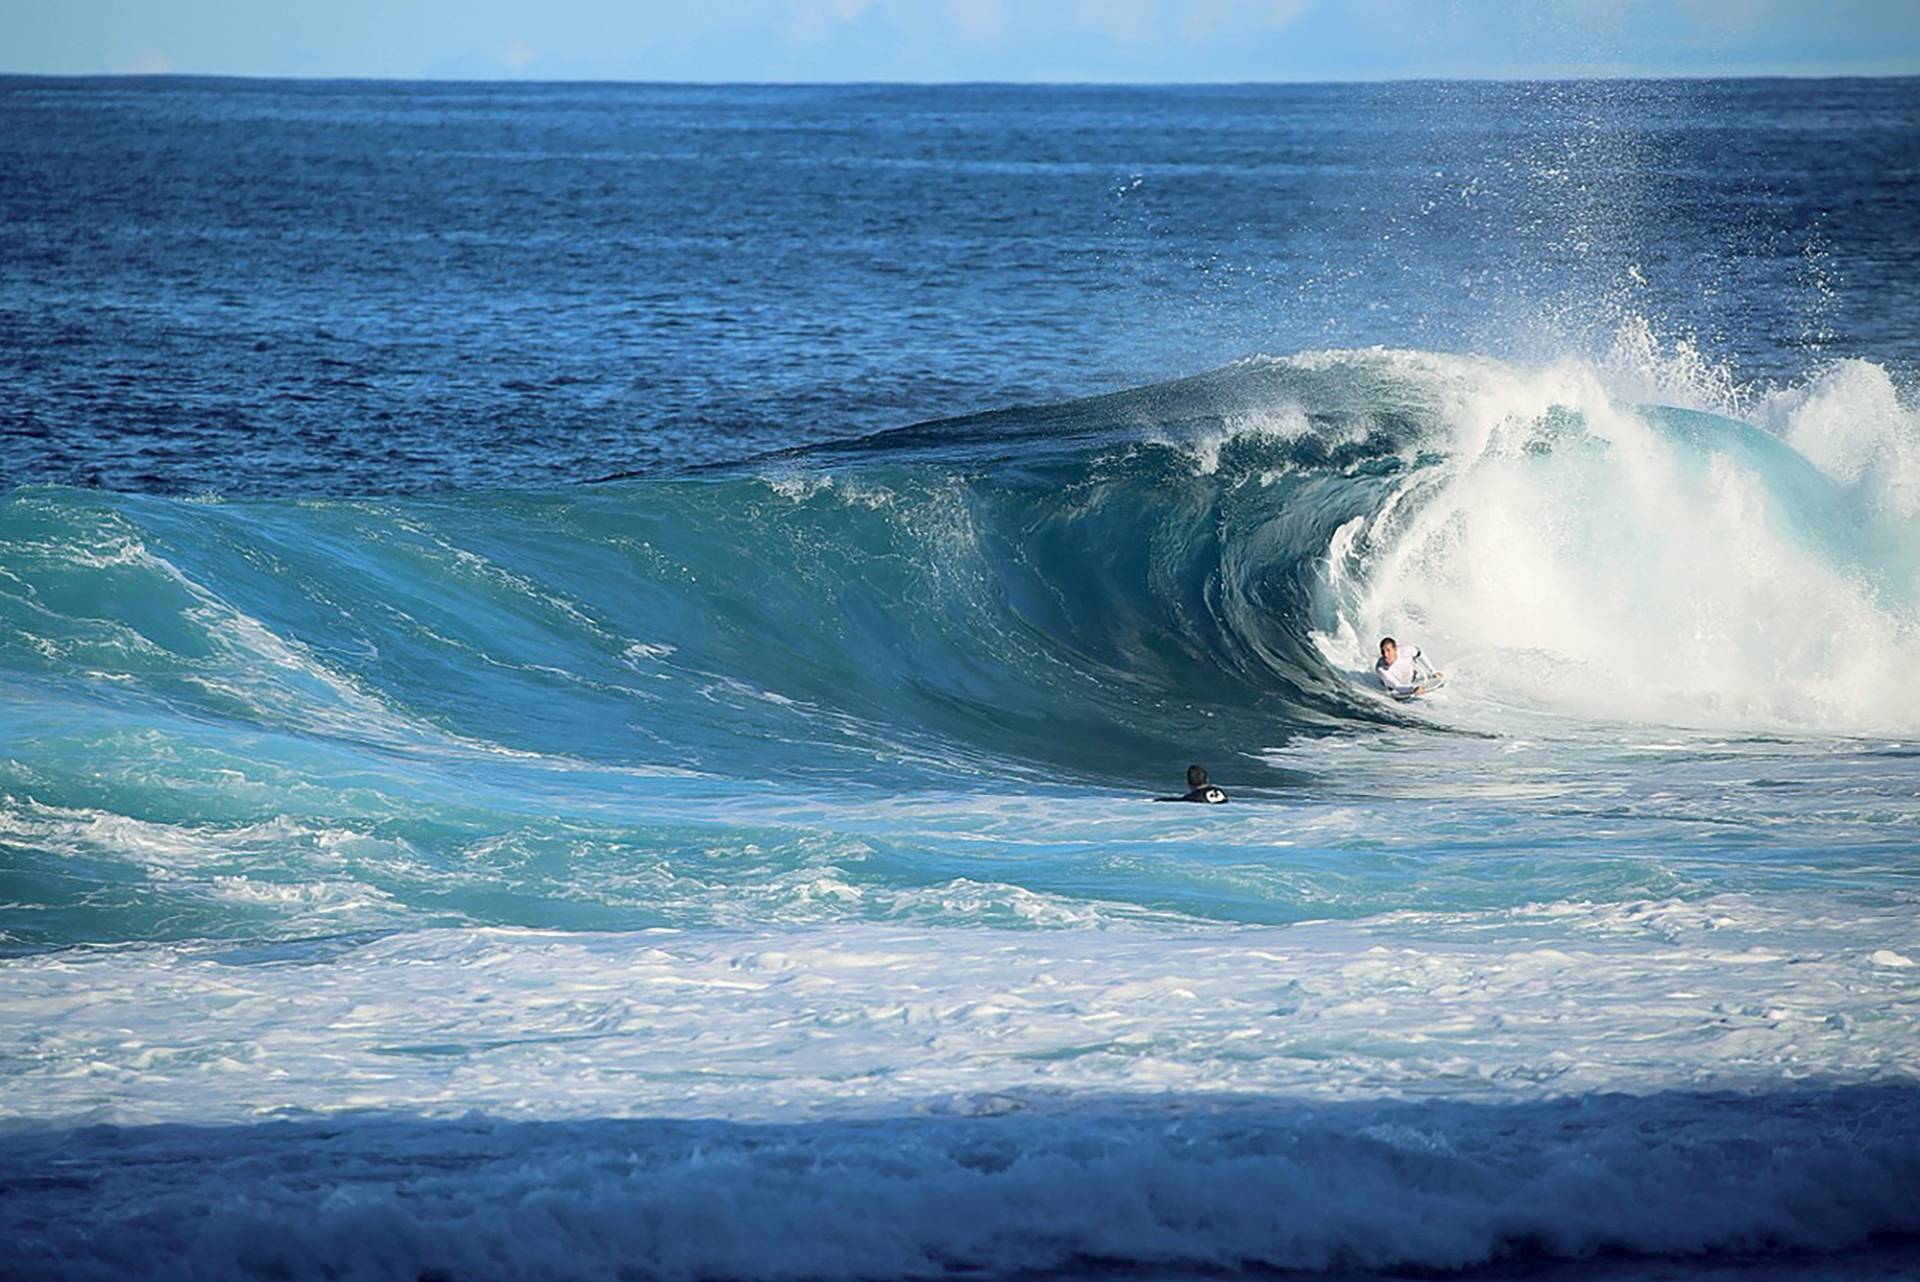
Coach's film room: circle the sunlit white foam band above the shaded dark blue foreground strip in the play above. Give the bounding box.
[0,881,1920,1123]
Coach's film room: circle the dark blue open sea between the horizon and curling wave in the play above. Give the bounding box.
[0,79,1920,495]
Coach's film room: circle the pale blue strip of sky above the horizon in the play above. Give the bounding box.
[0,0,1920,83]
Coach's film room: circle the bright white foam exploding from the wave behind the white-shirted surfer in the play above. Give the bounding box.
[1321,353,1920,733]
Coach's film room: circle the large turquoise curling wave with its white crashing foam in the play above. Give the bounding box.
[0,351,1920,787]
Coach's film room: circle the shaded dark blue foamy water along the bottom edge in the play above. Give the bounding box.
[0,1082,1920,1282]
